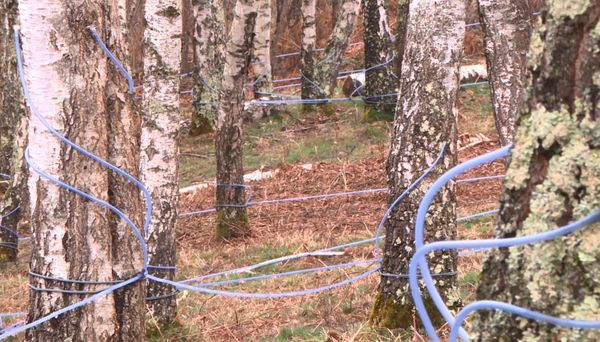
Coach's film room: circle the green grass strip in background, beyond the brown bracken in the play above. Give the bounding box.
[179,103,390,186]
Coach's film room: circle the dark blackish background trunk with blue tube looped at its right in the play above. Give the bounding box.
[362,0,398,113]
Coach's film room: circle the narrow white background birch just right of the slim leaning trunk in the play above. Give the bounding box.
[251,0,273,119]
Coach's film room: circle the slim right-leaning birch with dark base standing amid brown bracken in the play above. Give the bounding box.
[215,0,256,239]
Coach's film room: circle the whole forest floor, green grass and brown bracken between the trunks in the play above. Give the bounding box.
[0,87,504,341]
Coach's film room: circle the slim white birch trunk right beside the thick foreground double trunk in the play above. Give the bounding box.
[141,0,182,324]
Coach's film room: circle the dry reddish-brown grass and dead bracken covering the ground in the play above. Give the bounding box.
[0,67,503,341]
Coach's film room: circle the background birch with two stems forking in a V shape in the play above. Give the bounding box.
[302,0,360,105]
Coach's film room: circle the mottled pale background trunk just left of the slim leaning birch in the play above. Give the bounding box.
[190,0,225,135]
